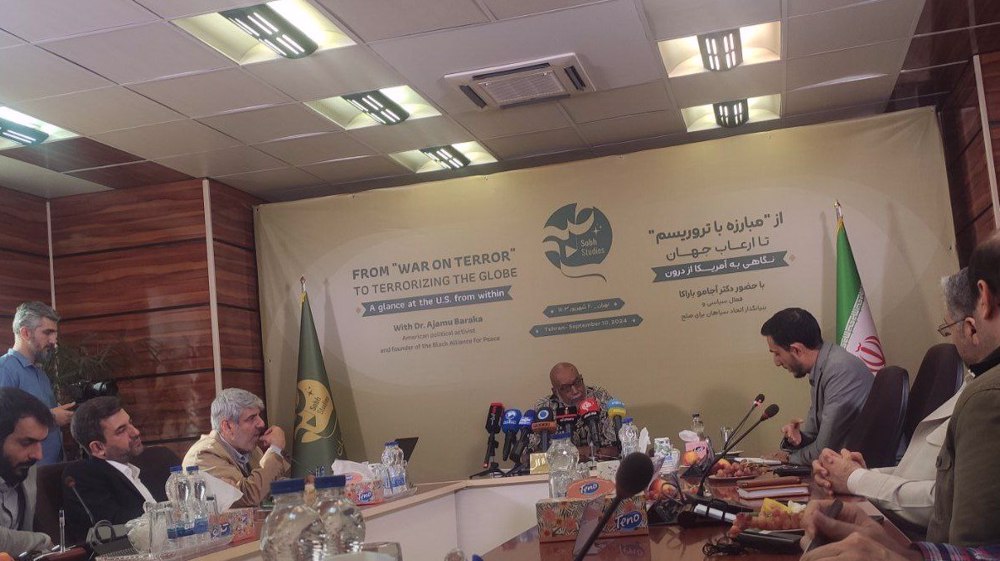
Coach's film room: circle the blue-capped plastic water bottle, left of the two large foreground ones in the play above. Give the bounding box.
[260,479,325,561]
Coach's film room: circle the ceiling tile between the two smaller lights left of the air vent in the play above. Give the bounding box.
[347,117,472,154]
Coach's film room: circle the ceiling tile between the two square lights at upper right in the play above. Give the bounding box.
[668,61,785,107]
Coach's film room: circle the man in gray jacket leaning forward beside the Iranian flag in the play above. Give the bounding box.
[760,308,875,465]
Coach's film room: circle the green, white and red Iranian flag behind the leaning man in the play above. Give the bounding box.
[836,202,885,374]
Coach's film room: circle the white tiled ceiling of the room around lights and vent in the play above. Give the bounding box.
[0,0,1000,200]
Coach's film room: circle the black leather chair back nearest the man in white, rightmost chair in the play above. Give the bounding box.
[903,343,965,448]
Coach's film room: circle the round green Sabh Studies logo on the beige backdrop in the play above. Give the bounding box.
[542,203,612,281]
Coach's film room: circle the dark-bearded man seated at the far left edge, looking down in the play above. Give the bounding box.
[0,388,55,556]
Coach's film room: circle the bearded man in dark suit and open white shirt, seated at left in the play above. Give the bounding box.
[63,397,166,543]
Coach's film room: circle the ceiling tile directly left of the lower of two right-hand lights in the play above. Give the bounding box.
[560,80,674,123]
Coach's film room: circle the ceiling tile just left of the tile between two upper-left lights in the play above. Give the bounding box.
[129,68,292,117]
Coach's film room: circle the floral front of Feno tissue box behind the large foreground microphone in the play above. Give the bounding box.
[535,494,649,542]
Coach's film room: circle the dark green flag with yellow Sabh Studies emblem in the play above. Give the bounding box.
[292,290,344,477]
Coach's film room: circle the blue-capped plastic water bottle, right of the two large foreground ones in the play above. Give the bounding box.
[310,475,365,559]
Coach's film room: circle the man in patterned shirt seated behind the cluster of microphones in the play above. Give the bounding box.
[525,362,619,461]
